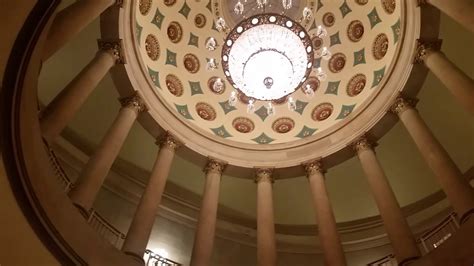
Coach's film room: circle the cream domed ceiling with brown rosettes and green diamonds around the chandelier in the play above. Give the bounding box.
[134,0,402,145]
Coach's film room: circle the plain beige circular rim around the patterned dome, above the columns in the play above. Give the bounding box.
[109,0,430,168]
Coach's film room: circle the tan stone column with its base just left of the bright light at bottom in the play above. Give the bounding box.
[122,134,180,260]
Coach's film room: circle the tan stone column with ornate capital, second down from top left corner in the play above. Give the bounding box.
[40,41,123,142]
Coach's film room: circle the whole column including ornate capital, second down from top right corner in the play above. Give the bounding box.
[415,39,474,114]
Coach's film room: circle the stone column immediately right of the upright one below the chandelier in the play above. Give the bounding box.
[303,161,346,266]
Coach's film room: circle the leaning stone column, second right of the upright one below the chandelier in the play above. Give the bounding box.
[354,137,421,265]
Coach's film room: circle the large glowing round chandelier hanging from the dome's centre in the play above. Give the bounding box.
[206,0,331,115]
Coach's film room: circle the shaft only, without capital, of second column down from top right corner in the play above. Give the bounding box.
[424,51,474,114]
